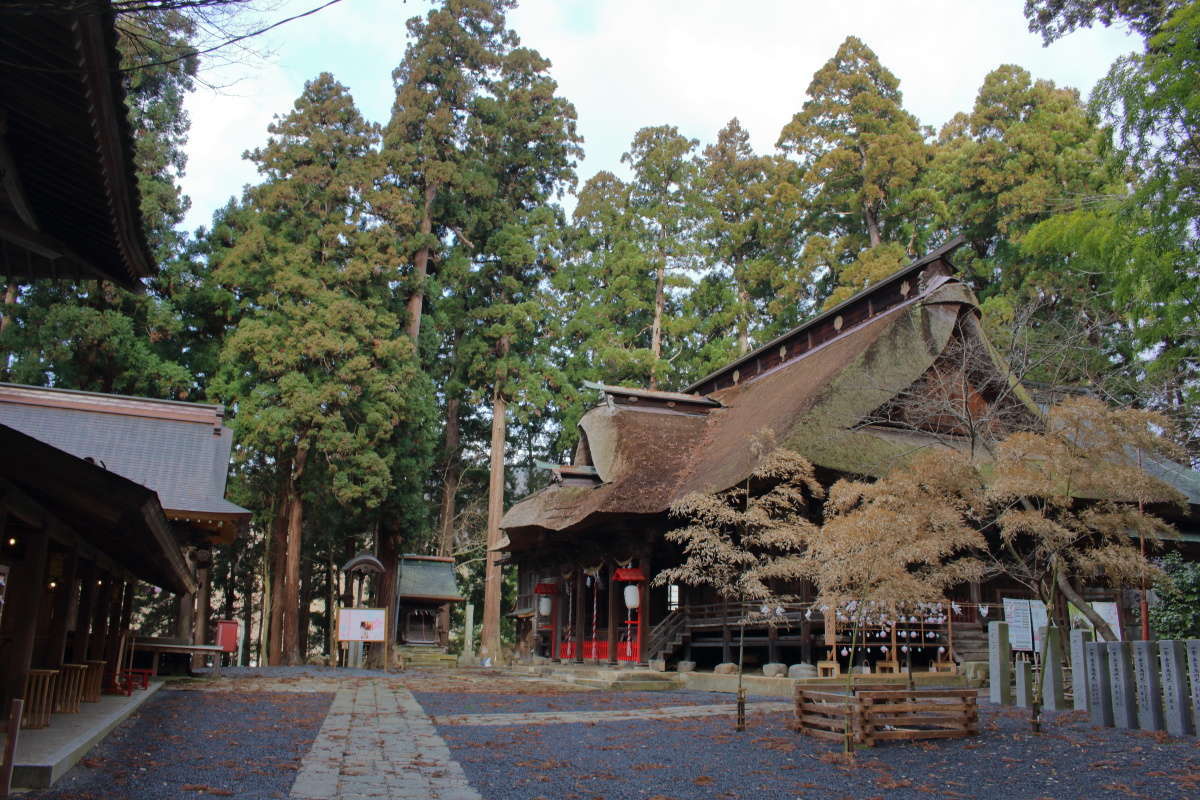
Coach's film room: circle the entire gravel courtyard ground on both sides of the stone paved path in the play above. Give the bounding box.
[18,667,1200,800]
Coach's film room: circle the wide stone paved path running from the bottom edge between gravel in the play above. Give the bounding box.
[290,680,481,800]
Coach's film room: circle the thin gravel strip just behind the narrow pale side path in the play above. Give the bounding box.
[412,685,734,716]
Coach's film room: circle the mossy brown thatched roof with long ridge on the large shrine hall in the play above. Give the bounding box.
[500,241,1027,549]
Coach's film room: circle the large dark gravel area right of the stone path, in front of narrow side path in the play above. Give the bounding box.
[438,705,1200,800]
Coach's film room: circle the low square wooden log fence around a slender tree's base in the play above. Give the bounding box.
[796,686,979,747]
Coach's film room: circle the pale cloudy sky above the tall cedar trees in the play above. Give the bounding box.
[175,0,1140,230]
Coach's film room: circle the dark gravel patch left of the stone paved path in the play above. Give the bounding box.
[20,690,334,800]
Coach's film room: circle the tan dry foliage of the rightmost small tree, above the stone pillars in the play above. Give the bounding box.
[988,397,1184,640]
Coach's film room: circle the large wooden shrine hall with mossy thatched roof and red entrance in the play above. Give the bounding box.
[502,241,1200,664]
